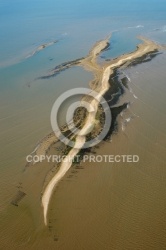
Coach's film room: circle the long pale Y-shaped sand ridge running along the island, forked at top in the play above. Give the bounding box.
[42,34,163,225]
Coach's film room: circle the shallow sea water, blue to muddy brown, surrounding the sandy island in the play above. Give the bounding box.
[0,0,166,250]
